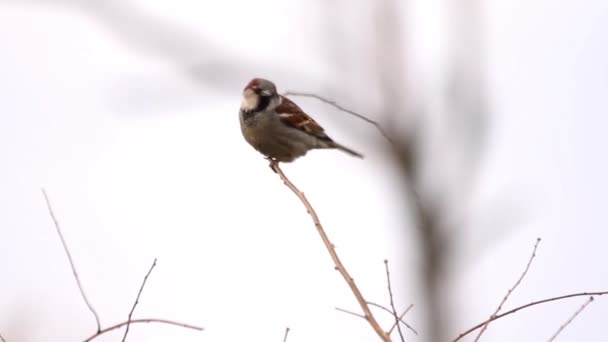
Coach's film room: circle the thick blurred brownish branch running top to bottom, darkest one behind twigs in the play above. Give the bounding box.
[370,0,454,342]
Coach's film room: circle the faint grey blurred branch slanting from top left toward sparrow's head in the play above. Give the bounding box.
[0,0,319,91]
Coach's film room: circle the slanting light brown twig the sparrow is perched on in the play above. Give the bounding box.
[271,163,391,342]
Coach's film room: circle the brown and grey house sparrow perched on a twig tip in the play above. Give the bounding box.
[239,78,363,170]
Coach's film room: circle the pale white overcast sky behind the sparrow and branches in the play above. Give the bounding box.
[0,0,608,342]
